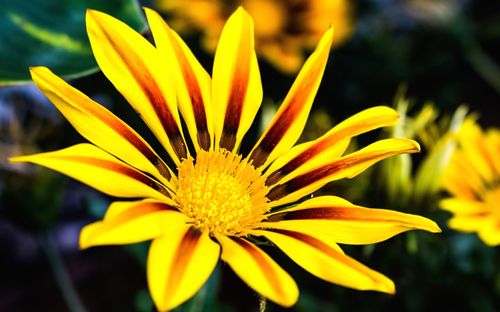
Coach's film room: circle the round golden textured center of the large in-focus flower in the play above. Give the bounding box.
[175,150,269,236]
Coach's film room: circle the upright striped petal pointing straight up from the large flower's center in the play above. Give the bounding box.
[212,7,262,151]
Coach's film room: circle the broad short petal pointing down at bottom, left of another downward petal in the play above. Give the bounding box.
[147,226,220,311]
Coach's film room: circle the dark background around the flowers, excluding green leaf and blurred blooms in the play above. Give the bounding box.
[0,0,500,312]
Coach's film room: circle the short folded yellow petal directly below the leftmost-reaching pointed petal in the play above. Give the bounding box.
[80,200,188,248]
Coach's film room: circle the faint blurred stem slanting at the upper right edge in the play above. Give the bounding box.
[466,44,500,94]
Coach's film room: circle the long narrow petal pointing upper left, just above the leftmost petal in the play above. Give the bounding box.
[30,67,171,183]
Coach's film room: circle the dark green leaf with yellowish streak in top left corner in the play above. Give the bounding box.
[0,0,147,85]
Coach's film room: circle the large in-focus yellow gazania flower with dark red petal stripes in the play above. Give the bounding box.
[14,9,439,310]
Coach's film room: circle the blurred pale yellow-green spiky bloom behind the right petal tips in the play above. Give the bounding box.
[377,87,467,209]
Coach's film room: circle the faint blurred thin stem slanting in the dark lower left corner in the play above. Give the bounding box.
[40,234,86,312]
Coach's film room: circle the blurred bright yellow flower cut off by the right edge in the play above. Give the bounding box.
[440,118,500,246]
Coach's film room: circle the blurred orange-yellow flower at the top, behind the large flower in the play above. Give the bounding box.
[156,0,355,73]
